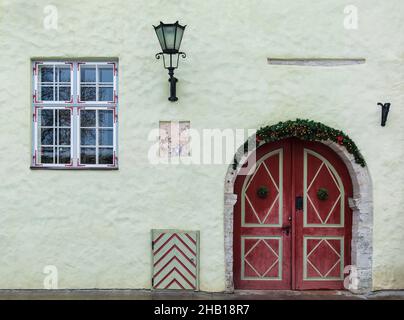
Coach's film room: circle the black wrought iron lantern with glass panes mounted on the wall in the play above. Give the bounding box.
[153,21,186,102]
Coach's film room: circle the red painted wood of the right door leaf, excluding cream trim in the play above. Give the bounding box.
[293,141,353,290]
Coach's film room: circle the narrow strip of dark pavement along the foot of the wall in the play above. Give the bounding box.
[0,289,404,300]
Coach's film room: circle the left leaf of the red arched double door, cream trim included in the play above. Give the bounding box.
[234,143,291,289]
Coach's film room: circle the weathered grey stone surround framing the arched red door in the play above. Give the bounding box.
[224,122,373,292]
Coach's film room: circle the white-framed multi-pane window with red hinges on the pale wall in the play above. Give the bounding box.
[32,61,118,169]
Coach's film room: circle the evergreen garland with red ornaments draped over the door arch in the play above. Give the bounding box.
[233,119,366,168]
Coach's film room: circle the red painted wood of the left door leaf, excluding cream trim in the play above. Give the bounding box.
[234,142,292,289]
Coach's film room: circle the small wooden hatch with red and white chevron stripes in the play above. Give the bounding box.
[152,230,199,290]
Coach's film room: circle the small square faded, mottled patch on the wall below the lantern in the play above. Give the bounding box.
[159,121,191,158]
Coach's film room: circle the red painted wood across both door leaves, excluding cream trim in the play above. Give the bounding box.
[233,139,352,290]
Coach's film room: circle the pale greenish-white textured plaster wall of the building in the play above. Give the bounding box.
[0,0,404,291]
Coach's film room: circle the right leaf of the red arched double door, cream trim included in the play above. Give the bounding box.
[292,141,352,290]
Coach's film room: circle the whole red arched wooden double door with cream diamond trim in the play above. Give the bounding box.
[233,139,352,290]
